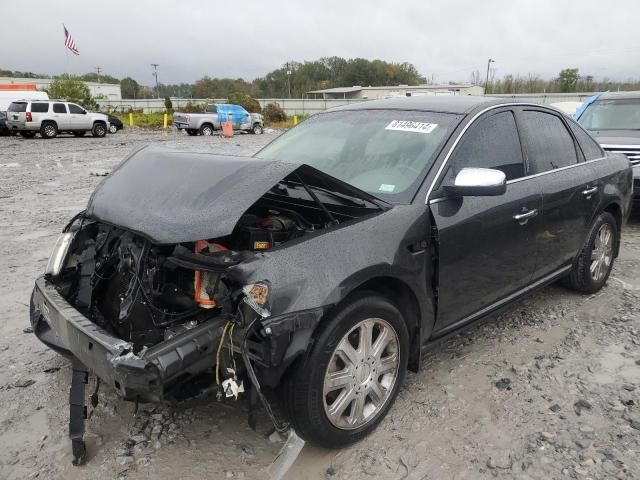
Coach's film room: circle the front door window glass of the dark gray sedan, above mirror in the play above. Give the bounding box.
[447,112,524,180]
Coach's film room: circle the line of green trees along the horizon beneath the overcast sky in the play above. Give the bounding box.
[0,62,640,98]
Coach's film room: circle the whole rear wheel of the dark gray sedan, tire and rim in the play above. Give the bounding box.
[566,212,619,293]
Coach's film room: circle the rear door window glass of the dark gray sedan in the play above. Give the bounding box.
[522,110,578,174]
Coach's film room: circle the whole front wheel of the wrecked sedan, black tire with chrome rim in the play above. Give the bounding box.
[283,294,409,448]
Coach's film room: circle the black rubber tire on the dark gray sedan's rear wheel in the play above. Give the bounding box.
[565,212,619,293]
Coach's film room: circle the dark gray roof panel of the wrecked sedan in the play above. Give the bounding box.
[327,95,507,114]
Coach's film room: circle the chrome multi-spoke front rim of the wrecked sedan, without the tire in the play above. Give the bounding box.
[322,318,400,430]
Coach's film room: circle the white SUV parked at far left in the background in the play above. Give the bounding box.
[7,100,109,138]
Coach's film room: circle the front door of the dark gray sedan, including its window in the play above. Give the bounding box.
[429,109,542,333]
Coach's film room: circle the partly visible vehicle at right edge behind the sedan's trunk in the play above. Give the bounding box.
[577,92,640,205]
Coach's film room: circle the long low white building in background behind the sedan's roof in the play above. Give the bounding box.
[307,84,484,100]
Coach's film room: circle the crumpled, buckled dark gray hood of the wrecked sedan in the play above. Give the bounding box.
[87,147,385,244]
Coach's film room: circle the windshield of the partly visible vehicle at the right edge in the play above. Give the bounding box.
[578,98,640,130]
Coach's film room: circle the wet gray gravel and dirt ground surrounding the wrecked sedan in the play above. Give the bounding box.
[0,131,640,480]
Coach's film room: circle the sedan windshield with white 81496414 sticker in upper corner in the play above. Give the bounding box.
[256,110,461,203]
